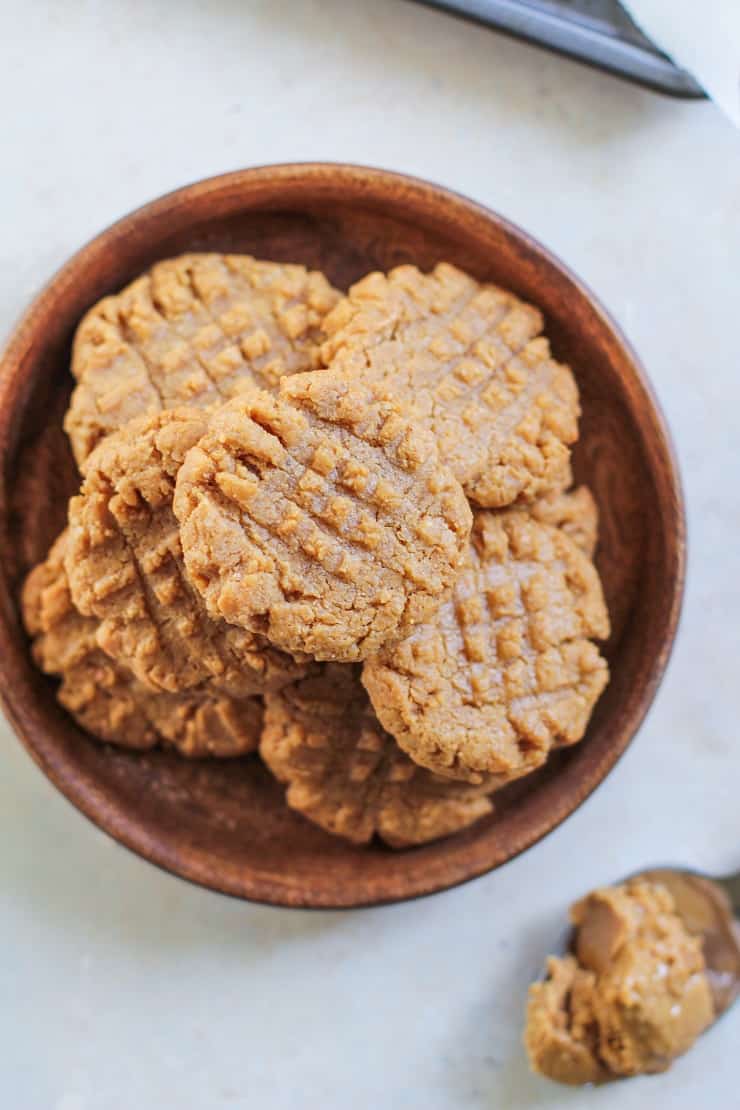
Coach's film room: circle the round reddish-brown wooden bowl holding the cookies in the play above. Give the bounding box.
[0,164,685,907]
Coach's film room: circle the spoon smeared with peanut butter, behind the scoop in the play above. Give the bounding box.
[562,867,740,1019]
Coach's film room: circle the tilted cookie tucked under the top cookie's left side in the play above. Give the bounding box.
[65,410,304,697]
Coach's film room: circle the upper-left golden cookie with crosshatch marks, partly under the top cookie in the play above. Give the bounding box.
[64,254,338,464]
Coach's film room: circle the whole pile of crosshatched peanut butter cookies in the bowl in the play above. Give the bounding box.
[23,254,609,847]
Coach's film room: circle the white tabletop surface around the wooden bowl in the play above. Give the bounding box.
[0,0,740,1110]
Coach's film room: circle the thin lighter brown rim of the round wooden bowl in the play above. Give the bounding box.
[0,162,687,909]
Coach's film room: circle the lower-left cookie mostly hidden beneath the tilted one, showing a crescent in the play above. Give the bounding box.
[22,532,262,757]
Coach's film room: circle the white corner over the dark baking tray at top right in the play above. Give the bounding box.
[624,0,740,125]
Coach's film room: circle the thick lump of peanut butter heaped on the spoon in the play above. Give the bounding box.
[525,880,714,1084]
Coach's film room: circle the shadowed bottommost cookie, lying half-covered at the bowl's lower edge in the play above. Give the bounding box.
[260,664,493,848]
